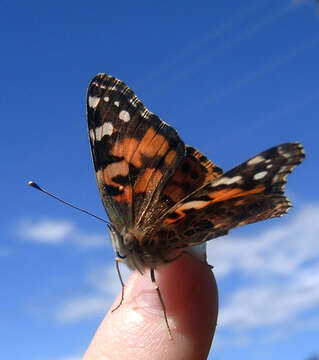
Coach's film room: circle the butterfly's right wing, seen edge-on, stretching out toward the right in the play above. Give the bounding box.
[157,143,305,247]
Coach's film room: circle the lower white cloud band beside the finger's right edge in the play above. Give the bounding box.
[220,264,319,329]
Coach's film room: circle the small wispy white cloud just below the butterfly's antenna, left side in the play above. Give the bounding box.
[18,219,109,248]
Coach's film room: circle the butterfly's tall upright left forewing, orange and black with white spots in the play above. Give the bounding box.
[87,74,185,232]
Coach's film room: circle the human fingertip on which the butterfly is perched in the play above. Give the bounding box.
[83,256,218,360]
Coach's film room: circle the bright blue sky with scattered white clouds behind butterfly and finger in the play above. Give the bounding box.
[0,0,319,360]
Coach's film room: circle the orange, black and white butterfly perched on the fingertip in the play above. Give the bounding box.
[87,74,305,338]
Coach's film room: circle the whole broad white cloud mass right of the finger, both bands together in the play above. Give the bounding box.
[208,205,319,337]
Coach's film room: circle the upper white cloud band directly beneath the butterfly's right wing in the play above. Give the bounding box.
[208,205,319,277]
